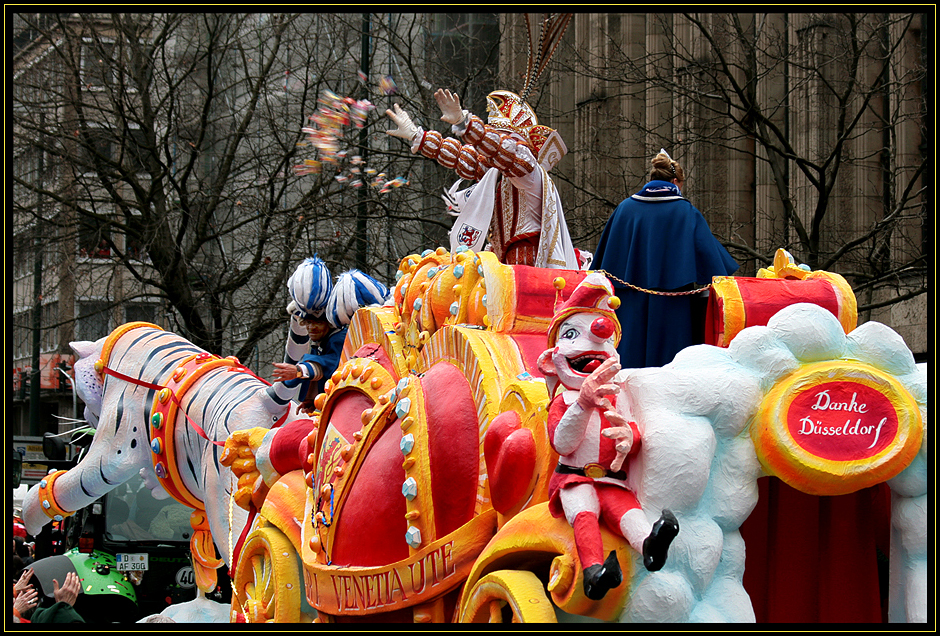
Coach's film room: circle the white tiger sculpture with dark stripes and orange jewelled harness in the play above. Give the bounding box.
[23,323,306,591]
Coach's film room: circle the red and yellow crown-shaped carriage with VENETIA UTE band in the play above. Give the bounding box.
[236,249,583,622]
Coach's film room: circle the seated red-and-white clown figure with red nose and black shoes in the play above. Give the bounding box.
[538,273,679,600]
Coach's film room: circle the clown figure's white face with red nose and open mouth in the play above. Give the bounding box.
[551,312,617,390]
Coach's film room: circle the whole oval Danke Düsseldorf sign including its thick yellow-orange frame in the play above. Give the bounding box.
[751,360,924,496]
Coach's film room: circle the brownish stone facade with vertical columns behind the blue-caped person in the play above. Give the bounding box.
[500,13,933,360]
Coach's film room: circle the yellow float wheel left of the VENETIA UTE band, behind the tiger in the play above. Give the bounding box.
[233,526,304,623]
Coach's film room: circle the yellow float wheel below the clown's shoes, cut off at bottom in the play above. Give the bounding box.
[460,570,556,623]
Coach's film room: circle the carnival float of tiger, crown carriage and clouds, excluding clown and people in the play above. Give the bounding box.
[24,248,929,622]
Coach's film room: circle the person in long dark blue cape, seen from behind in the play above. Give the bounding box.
[593,150,738,368]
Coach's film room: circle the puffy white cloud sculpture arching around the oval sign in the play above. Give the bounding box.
[618,303,929,622]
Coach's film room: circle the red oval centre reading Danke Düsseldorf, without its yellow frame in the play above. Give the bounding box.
[787,381,898,461]
